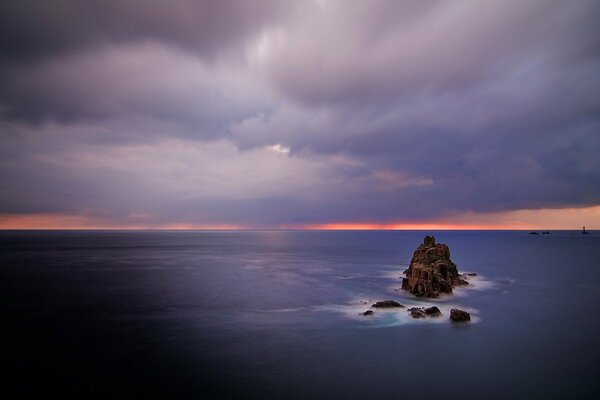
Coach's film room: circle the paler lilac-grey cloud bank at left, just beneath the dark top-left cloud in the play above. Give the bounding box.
[0,43,268,126]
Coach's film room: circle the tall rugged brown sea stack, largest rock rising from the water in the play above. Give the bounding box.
[402,236,468,298]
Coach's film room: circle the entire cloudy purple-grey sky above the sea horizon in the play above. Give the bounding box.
[0,0,600,229]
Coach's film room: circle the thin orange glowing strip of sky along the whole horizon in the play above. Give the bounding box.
[0,206,600,230]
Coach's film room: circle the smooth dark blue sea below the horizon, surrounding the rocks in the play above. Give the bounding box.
[0,231,600,400]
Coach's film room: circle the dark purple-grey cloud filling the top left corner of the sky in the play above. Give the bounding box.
[0,0,286,62]
